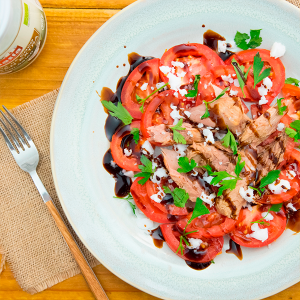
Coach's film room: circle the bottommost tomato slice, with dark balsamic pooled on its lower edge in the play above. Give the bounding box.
[160,224,224,263]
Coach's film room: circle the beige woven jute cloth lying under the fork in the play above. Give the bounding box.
[0,90,98,294]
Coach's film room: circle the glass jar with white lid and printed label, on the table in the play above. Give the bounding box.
[0,0,47,75]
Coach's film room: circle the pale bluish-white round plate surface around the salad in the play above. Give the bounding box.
[51,0,300,300]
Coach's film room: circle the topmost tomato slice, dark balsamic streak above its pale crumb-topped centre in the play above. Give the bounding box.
[160,43,224,85]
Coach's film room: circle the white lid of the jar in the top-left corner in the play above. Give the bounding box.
[0,0,22,55]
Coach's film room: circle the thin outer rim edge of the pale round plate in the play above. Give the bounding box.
[50,0,300,300]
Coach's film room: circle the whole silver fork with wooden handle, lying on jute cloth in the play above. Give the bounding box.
[0,106,108,300]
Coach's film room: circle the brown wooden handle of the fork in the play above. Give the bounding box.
[46,200,108,300]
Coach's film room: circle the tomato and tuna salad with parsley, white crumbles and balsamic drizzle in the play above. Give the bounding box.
[101,29,300,269]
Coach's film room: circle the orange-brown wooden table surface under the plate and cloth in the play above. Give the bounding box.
[0,0,300,300]
